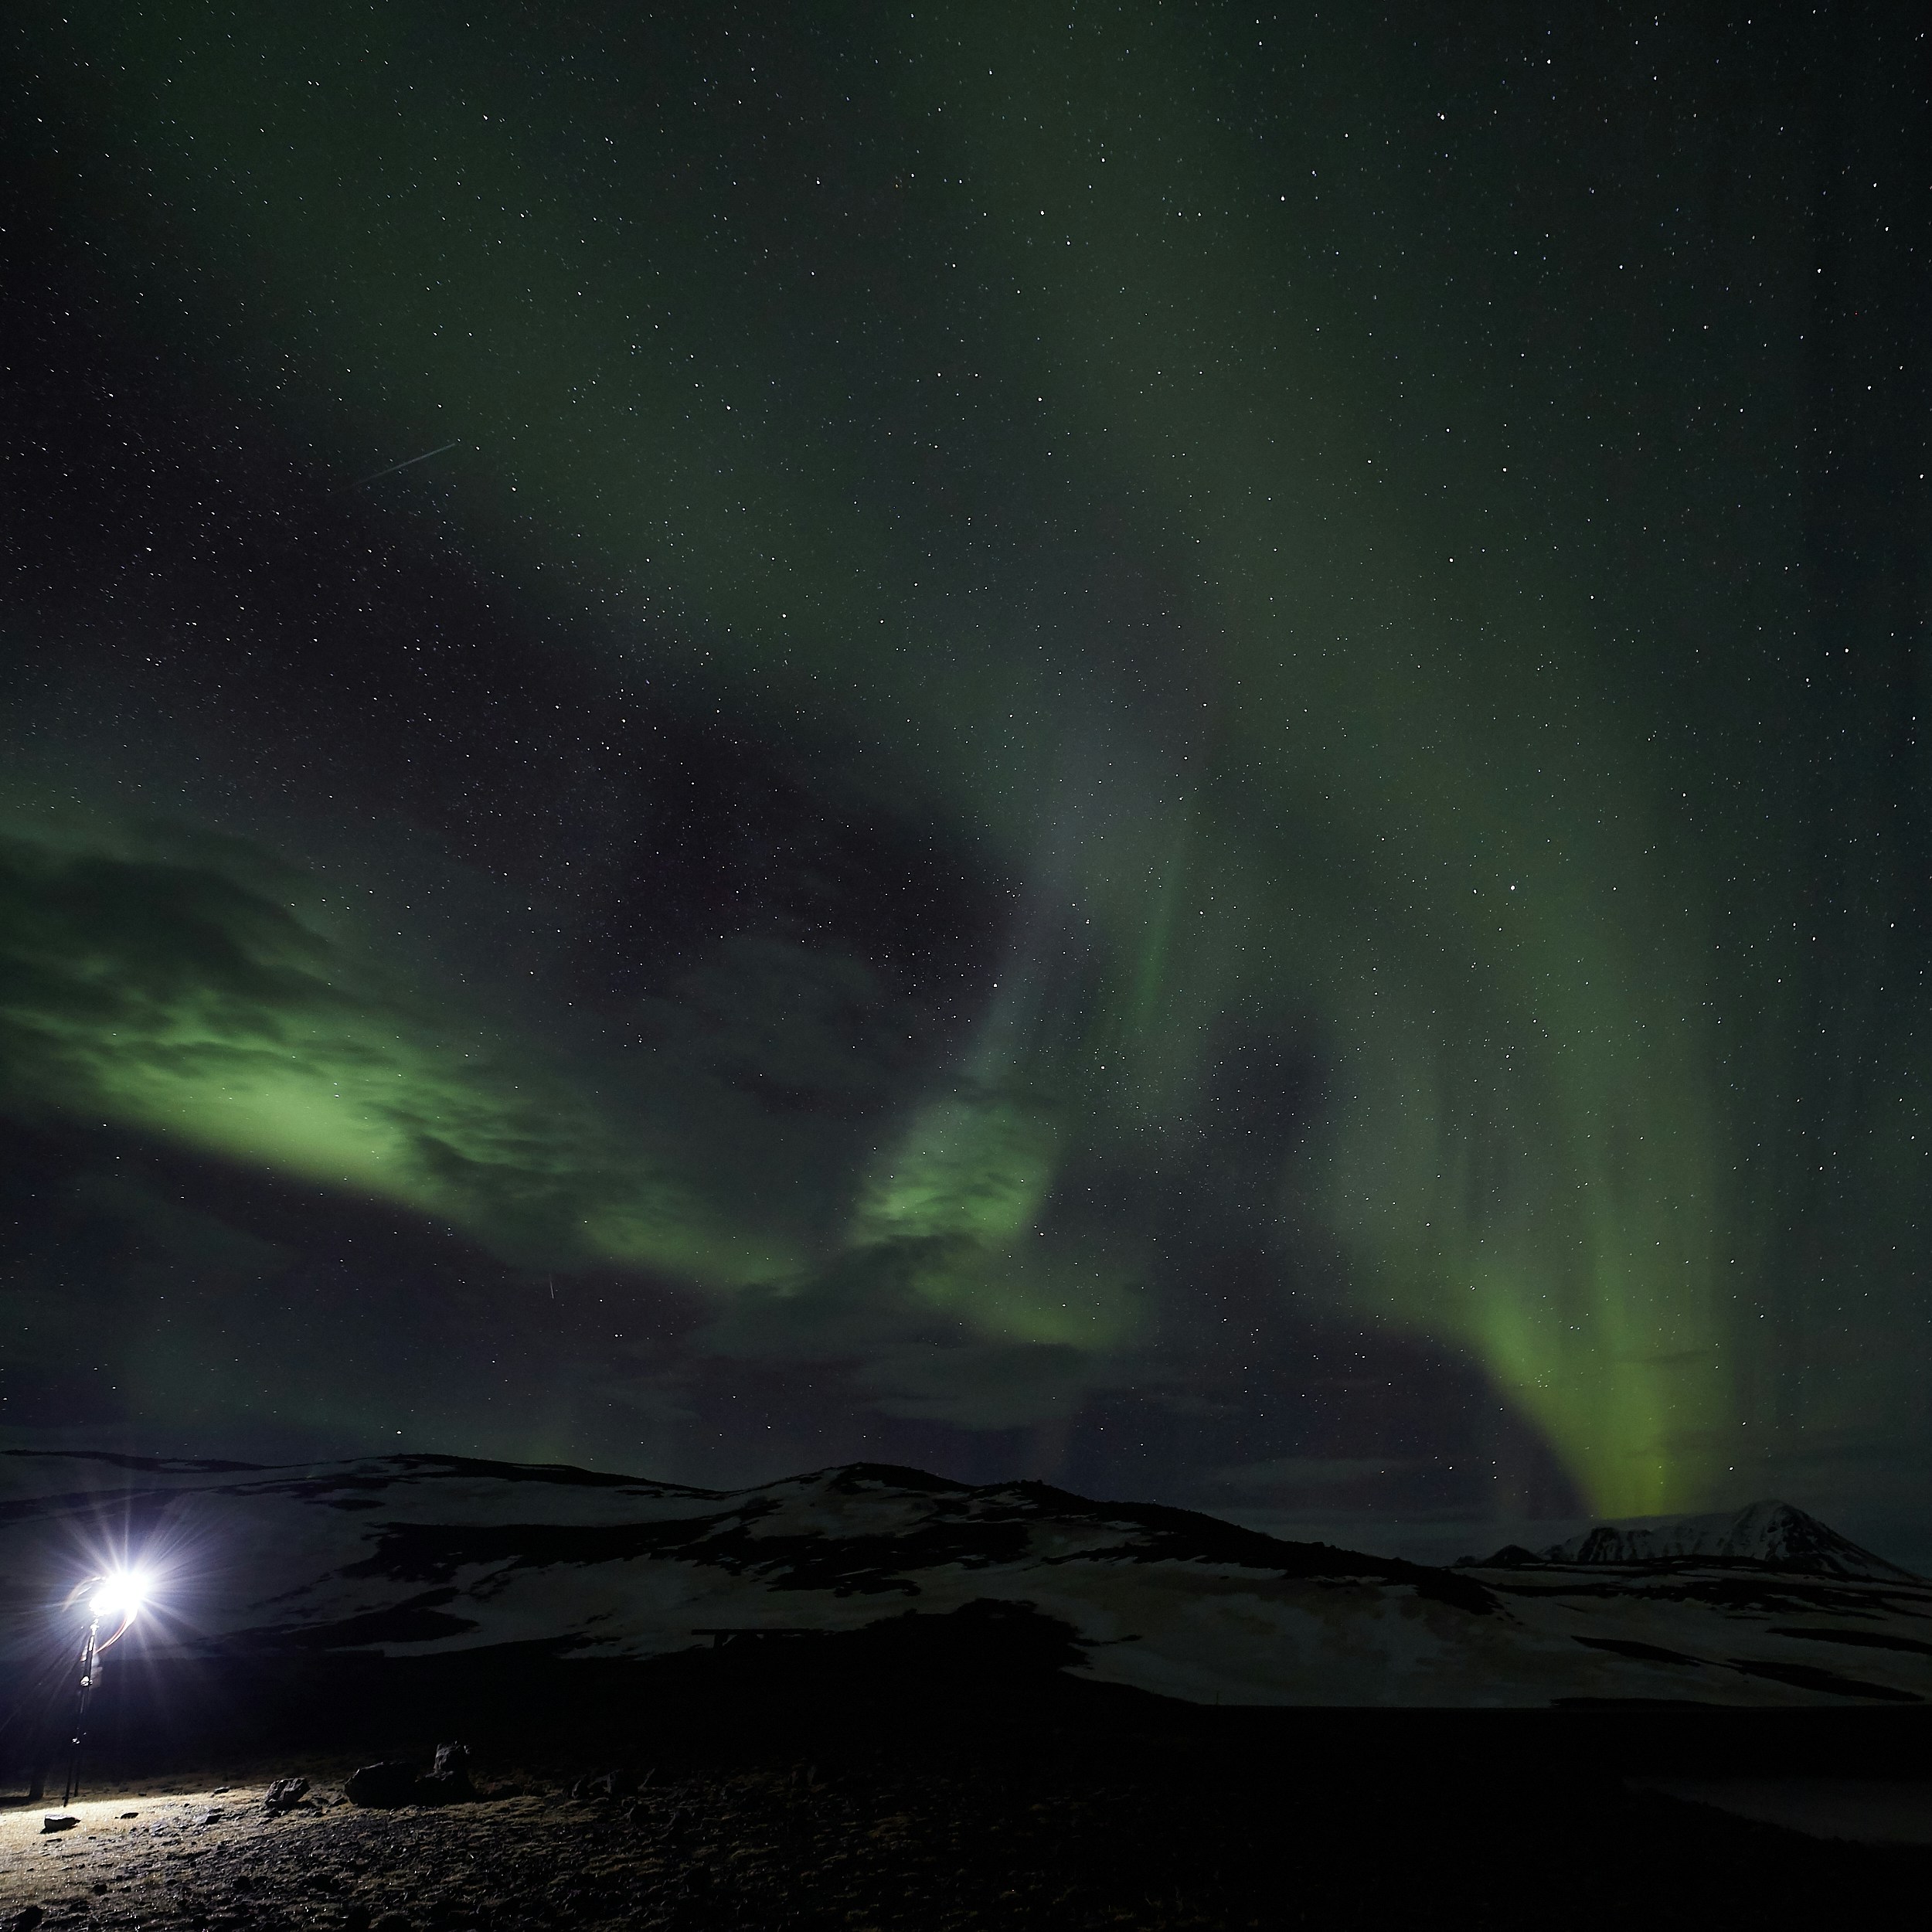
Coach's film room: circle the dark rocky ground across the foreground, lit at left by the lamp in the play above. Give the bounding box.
[11,1758,1932,1932]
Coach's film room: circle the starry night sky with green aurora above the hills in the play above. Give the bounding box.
[0,0,1932,1561]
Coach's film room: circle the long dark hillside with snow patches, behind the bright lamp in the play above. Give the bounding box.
[0,1451,1932,1706]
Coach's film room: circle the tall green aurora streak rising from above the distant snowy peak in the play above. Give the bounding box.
[877,14,1733,1513]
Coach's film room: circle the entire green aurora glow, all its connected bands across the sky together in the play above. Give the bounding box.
[15,0,1927,1515]
